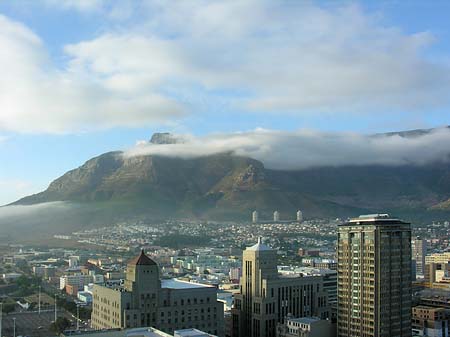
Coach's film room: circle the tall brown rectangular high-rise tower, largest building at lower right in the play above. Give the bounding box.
[338,214,411,337]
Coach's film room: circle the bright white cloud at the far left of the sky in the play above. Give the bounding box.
[0,16,182,133]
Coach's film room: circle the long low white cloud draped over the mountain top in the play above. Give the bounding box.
[124,128,450,170]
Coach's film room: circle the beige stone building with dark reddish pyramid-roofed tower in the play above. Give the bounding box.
[91,252,224,336]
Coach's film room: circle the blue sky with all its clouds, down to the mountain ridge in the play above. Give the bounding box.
[0,0,450,204]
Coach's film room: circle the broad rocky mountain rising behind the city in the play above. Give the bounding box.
[5,130,450,239]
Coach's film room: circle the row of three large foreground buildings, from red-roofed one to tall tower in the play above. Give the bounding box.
[92,214,428,337]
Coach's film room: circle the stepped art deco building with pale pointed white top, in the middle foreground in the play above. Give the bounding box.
[232,239,331,337]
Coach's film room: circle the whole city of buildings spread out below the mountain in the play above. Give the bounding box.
[7,214,450,337]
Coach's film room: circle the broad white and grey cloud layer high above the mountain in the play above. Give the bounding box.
[0,0,450,133]
